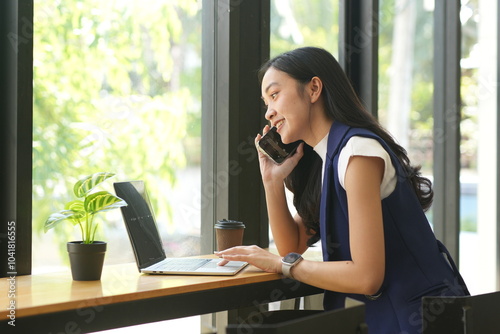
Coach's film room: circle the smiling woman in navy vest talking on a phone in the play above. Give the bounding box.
[217,47,468,334]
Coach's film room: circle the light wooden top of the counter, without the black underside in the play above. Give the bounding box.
[0,263,281,318]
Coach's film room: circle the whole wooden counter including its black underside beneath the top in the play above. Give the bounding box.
[0,252,322,333]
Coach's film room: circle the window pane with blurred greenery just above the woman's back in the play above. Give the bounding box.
[378,0,434,176]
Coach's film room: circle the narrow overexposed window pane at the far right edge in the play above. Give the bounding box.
[460,0,499,294]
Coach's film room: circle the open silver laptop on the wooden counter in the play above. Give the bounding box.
[113,181,247,275]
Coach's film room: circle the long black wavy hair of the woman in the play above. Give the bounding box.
[259,47,434,244]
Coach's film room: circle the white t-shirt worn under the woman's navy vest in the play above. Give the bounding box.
[314,134,397,199]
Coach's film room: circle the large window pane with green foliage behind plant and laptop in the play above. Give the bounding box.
[33,0,201,272]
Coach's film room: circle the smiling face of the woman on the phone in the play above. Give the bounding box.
[262,67,331,146]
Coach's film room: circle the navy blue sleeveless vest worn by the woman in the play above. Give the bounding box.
[320,121,469,334]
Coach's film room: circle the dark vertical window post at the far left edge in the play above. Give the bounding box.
[0,0,33,276]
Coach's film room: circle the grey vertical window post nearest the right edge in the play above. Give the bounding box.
[433,1,461,263]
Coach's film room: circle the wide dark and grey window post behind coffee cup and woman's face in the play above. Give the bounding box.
[201,0,270,253]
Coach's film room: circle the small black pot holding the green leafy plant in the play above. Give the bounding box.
[68,241,106,281]
